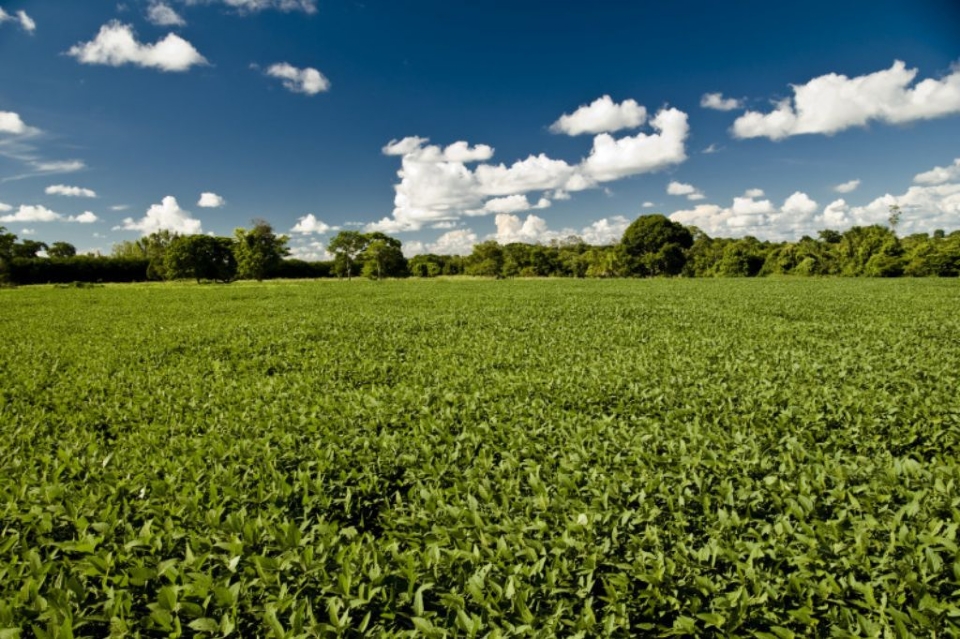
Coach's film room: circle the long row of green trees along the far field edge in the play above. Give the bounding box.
[0,214,960,284]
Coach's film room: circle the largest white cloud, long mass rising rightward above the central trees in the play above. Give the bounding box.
[378,109,688,233]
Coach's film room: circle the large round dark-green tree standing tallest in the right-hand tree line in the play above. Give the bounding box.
[620,214,693,276]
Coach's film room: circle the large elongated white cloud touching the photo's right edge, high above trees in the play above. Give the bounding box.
[732,60,960,140]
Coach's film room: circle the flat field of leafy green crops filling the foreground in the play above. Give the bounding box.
[0,279,960,639]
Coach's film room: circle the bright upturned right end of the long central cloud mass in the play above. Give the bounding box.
[583,109,690,182]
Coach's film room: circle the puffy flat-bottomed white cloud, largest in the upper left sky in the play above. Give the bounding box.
[67,20,207,71]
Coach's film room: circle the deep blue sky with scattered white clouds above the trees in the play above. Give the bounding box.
[0,0,960,259]
